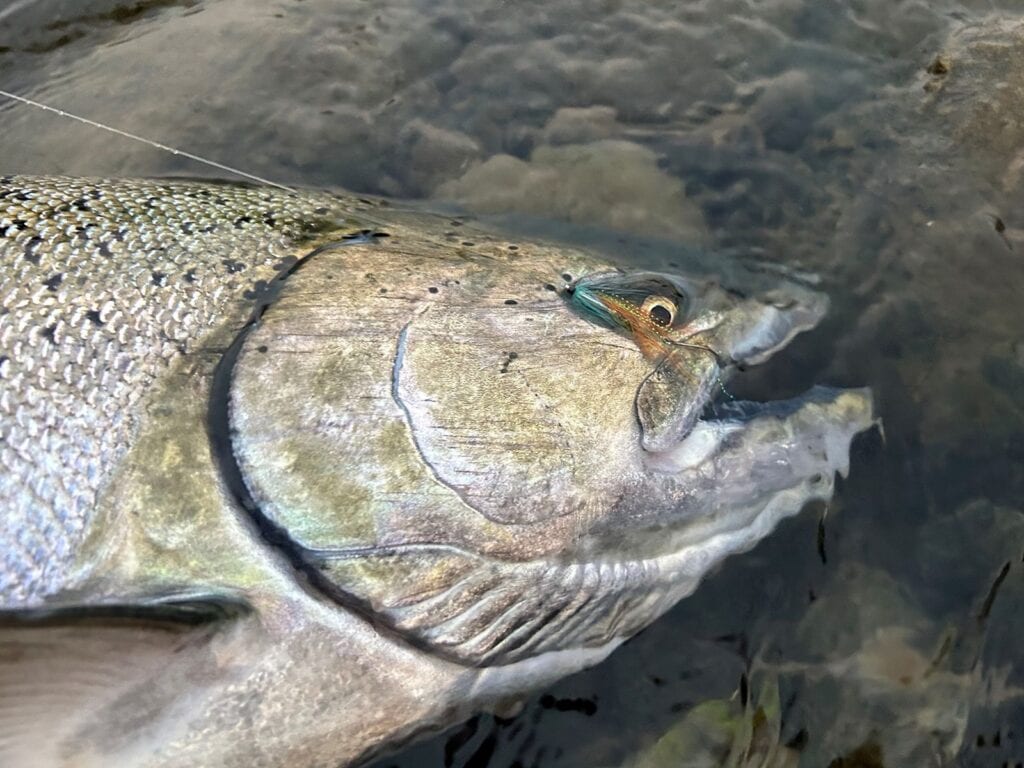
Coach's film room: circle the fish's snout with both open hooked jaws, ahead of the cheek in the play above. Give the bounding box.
[572,273,874,577]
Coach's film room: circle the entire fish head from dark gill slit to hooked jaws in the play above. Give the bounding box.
[229,237,873,674]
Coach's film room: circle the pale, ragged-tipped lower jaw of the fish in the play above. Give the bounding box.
[617,386,879,577]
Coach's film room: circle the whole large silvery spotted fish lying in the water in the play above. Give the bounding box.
[0,177,872,768]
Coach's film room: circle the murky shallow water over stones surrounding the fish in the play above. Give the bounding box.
[0,0,1024,768]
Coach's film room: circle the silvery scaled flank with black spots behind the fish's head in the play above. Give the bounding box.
[0,176,350,607]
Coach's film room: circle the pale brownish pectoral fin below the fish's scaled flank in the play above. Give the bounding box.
[0,596,258,768]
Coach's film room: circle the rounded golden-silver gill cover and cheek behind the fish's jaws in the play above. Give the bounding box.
[228,241,649,665]
